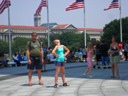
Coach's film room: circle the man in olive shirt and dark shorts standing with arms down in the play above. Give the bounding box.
[26,32,44,86]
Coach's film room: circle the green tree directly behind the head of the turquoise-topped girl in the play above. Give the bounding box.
[50,32,90,49]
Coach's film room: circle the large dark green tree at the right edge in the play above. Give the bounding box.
[101,17,128,44]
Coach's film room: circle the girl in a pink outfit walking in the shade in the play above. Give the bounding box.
[83,44,93,78]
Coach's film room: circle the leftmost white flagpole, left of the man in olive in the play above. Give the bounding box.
[8,7,12,60]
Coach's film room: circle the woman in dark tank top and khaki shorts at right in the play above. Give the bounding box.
[109,37,120,78]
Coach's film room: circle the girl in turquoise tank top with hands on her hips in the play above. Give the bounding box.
[52,39,70,88]
